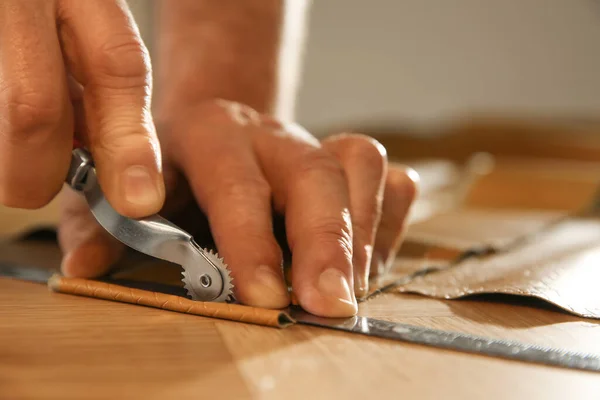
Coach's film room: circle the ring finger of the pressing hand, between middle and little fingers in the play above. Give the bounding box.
[323,134,387,298]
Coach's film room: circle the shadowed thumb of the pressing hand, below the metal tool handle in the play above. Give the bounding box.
[58,188,124,278]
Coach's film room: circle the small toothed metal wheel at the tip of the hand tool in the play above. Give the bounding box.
[181,248,234,303]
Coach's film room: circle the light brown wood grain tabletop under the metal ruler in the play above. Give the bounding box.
[0,270,600,399]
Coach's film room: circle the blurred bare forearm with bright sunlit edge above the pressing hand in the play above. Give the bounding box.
[155,0,307,118]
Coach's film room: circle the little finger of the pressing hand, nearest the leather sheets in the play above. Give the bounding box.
[370,164,419,276]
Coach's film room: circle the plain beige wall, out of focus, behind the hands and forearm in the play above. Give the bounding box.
[130,0,600,134]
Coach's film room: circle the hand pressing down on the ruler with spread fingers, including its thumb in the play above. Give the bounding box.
[60,101,417,316]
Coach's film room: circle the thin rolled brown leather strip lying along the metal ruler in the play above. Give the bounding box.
[48,275,294,328]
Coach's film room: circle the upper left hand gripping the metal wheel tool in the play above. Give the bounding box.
[0,0,165,217]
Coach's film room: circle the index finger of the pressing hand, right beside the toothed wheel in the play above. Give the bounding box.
[167,103,289,308]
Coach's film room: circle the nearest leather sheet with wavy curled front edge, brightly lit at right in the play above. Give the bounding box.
[386,218,600,319]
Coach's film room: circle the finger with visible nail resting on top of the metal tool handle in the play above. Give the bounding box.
[58,0,165,218]
